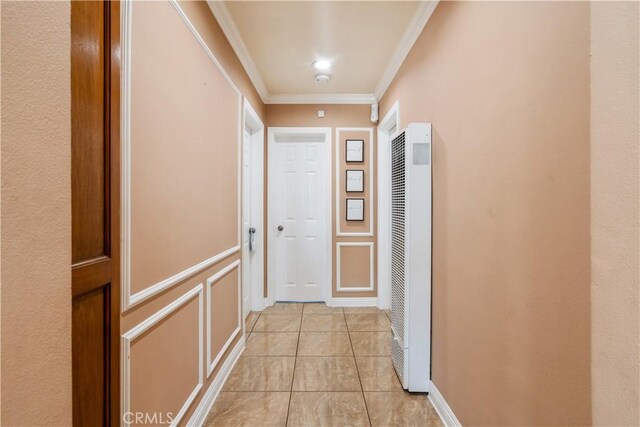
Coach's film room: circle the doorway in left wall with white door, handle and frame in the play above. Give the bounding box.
[241,98,264,319]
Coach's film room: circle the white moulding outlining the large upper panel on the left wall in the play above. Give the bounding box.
[120,0,242,312]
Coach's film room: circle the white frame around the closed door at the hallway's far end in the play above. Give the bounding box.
[265,127,333,307]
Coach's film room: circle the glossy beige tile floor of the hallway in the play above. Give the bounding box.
[205,303,442,427]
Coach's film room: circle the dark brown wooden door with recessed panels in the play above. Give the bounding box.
[71,1,120,426]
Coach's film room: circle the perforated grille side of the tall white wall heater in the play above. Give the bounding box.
[391,132,406,385]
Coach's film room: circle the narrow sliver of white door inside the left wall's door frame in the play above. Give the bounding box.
[242,128,253,318]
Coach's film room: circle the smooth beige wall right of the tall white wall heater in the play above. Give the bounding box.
[381,2,591,425]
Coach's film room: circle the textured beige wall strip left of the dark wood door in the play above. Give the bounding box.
[0,1,71,426]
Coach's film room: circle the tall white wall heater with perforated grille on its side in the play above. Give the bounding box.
[391,123,432,392]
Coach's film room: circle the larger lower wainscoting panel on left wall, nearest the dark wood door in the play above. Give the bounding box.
[122,284,204,425]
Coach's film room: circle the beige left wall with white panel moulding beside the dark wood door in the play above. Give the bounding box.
[121,2,264,425]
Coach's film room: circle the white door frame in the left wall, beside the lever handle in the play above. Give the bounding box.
[240,98,266,318]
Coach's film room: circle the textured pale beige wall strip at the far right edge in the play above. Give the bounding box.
[591,2,640,426]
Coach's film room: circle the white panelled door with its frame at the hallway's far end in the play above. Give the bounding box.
[268,128,331,304]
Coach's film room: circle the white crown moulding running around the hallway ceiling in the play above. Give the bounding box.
[207,0,439,104]
